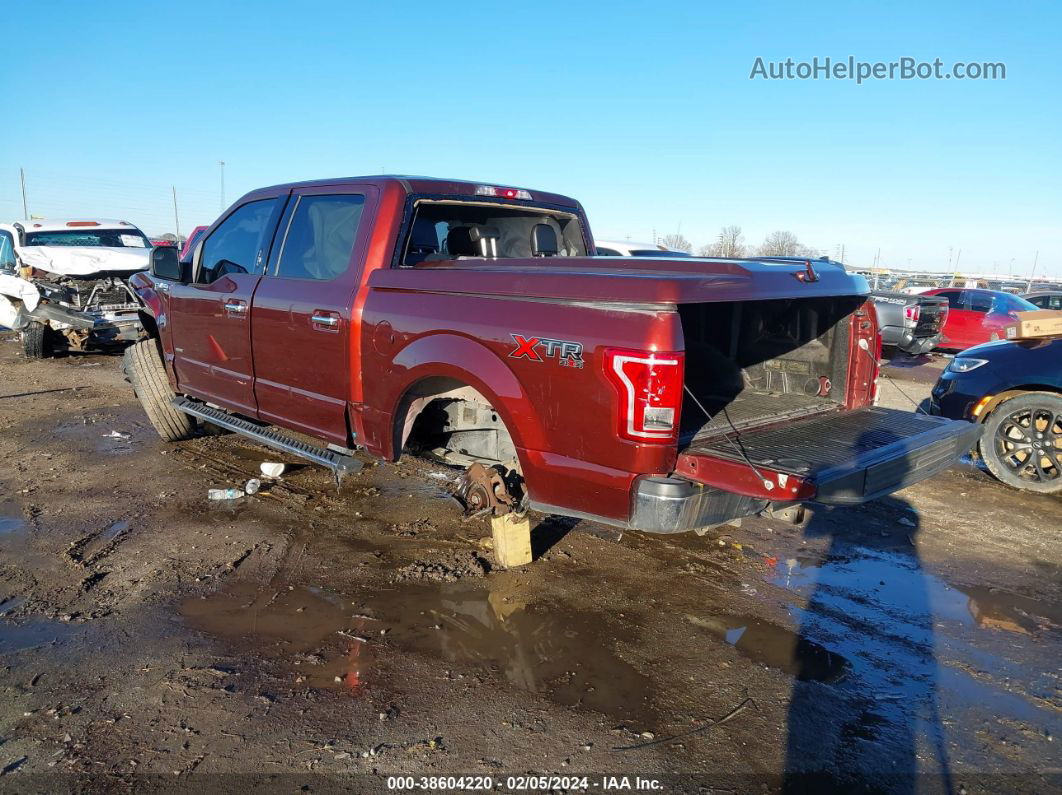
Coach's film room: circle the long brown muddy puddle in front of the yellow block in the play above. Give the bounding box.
[181,575,654,722]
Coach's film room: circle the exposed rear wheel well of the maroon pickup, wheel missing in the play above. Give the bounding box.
[394,377,520,471]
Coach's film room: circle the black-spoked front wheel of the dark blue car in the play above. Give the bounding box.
[979,392,1062,494]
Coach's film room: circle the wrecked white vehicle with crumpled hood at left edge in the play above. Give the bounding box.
[0,219,151,359]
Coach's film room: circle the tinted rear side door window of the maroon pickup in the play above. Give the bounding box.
[276,193,365,281]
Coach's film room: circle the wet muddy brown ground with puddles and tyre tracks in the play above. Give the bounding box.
[0,334,1062,793]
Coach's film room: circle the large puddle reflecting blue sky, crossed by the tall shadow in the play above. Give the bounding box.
[767,542,1062,733]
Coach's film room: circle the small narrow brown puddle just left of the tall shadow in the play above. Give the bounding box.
[686,616,849,682]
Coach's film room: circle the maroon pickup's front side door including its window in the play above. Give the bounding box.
[168,196,284,416]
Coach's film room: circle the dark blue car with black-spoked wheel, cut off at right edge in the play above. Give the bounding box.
[929,339,1062,494]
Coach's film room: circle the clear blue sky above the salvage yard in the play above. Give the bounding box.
[0,0,1062,276]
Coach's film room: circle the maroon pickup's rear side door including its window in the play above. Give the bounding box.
[251,184,376,446]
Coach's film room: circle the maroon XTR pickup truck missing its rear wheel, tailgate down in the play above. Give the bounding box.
[125,176,977,533]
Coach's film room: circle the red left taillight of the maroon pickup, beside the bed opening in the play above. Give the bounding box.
[604,348,685,444]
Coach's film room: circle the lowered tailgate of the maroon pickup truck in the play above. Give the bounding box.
[676,407,981,505]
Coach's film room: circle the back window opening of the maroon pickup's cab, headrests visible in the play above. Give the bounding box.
[398,198,586,267]
